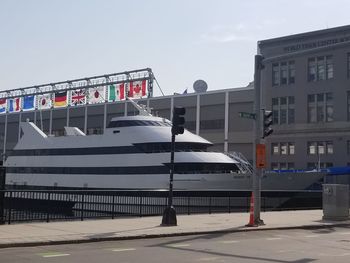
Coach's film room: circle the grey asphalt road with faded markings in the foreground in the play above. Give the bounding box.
[0,227,350,263]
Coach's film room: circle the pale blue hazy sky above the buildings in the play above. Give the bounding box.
[0,0,350,96]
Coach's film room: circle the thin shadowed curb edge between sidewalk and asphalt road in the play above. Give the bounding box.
[0,222,350,249]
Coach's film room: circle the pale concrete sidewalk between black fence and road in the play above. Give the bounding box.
[0,210,350,248]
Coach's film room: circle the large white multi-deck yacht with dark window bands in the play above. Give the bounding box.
[4,101,323,190]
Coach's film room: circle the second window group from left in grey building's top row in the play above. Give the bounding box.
[308,56,334,81]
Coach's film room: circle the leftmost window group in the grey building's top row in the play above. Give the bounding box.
[272,60,295,86]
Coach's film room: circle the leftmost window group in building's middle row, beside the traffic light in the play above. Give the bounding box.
[272,96,295,124]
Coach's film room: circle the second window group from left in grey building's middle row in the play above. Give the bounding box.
[307,92,333,123]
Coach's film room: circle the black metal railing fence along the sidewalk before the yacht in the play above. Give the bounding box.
[0,190,322,224]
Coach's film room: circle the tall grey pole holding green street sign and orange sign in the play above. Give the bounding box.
[253,55,264,225]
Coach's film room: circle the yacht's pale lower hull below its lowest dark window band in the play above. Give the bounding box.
[6,172,324,191]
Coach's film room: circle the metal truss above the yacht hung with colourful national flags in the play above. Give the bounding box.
[0,68,154,114]
